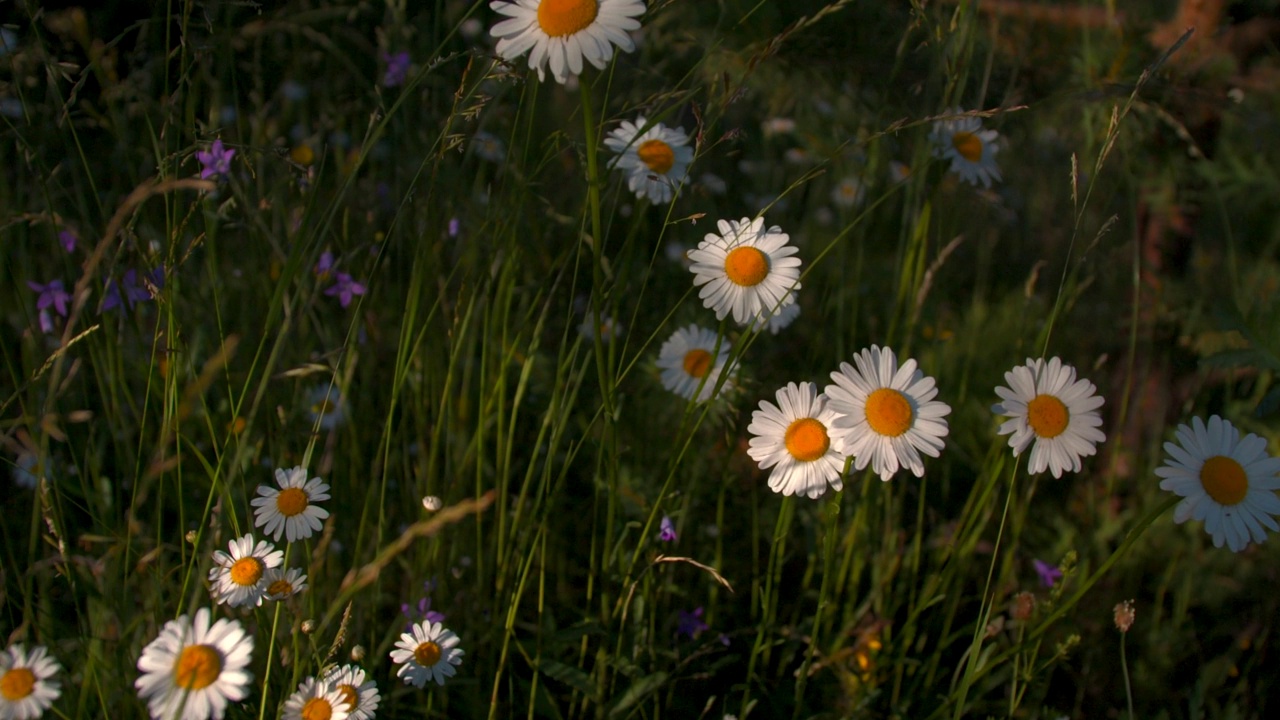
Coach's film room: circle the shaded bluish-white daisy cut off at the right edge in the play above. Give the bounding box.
[1156,415,1280,552]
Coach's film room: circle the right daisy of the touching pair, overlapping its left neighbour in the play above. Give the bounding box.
[826,345,951,480]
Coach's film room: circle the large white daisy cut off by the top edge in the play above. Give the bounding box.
[489,0,644,85]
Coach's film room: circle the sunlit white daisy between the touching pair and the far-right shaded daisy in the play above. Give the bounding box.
[991,357,1107,478]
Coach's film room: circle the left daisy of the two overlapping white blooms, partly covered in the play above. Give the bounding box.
[746,383,845,497]
